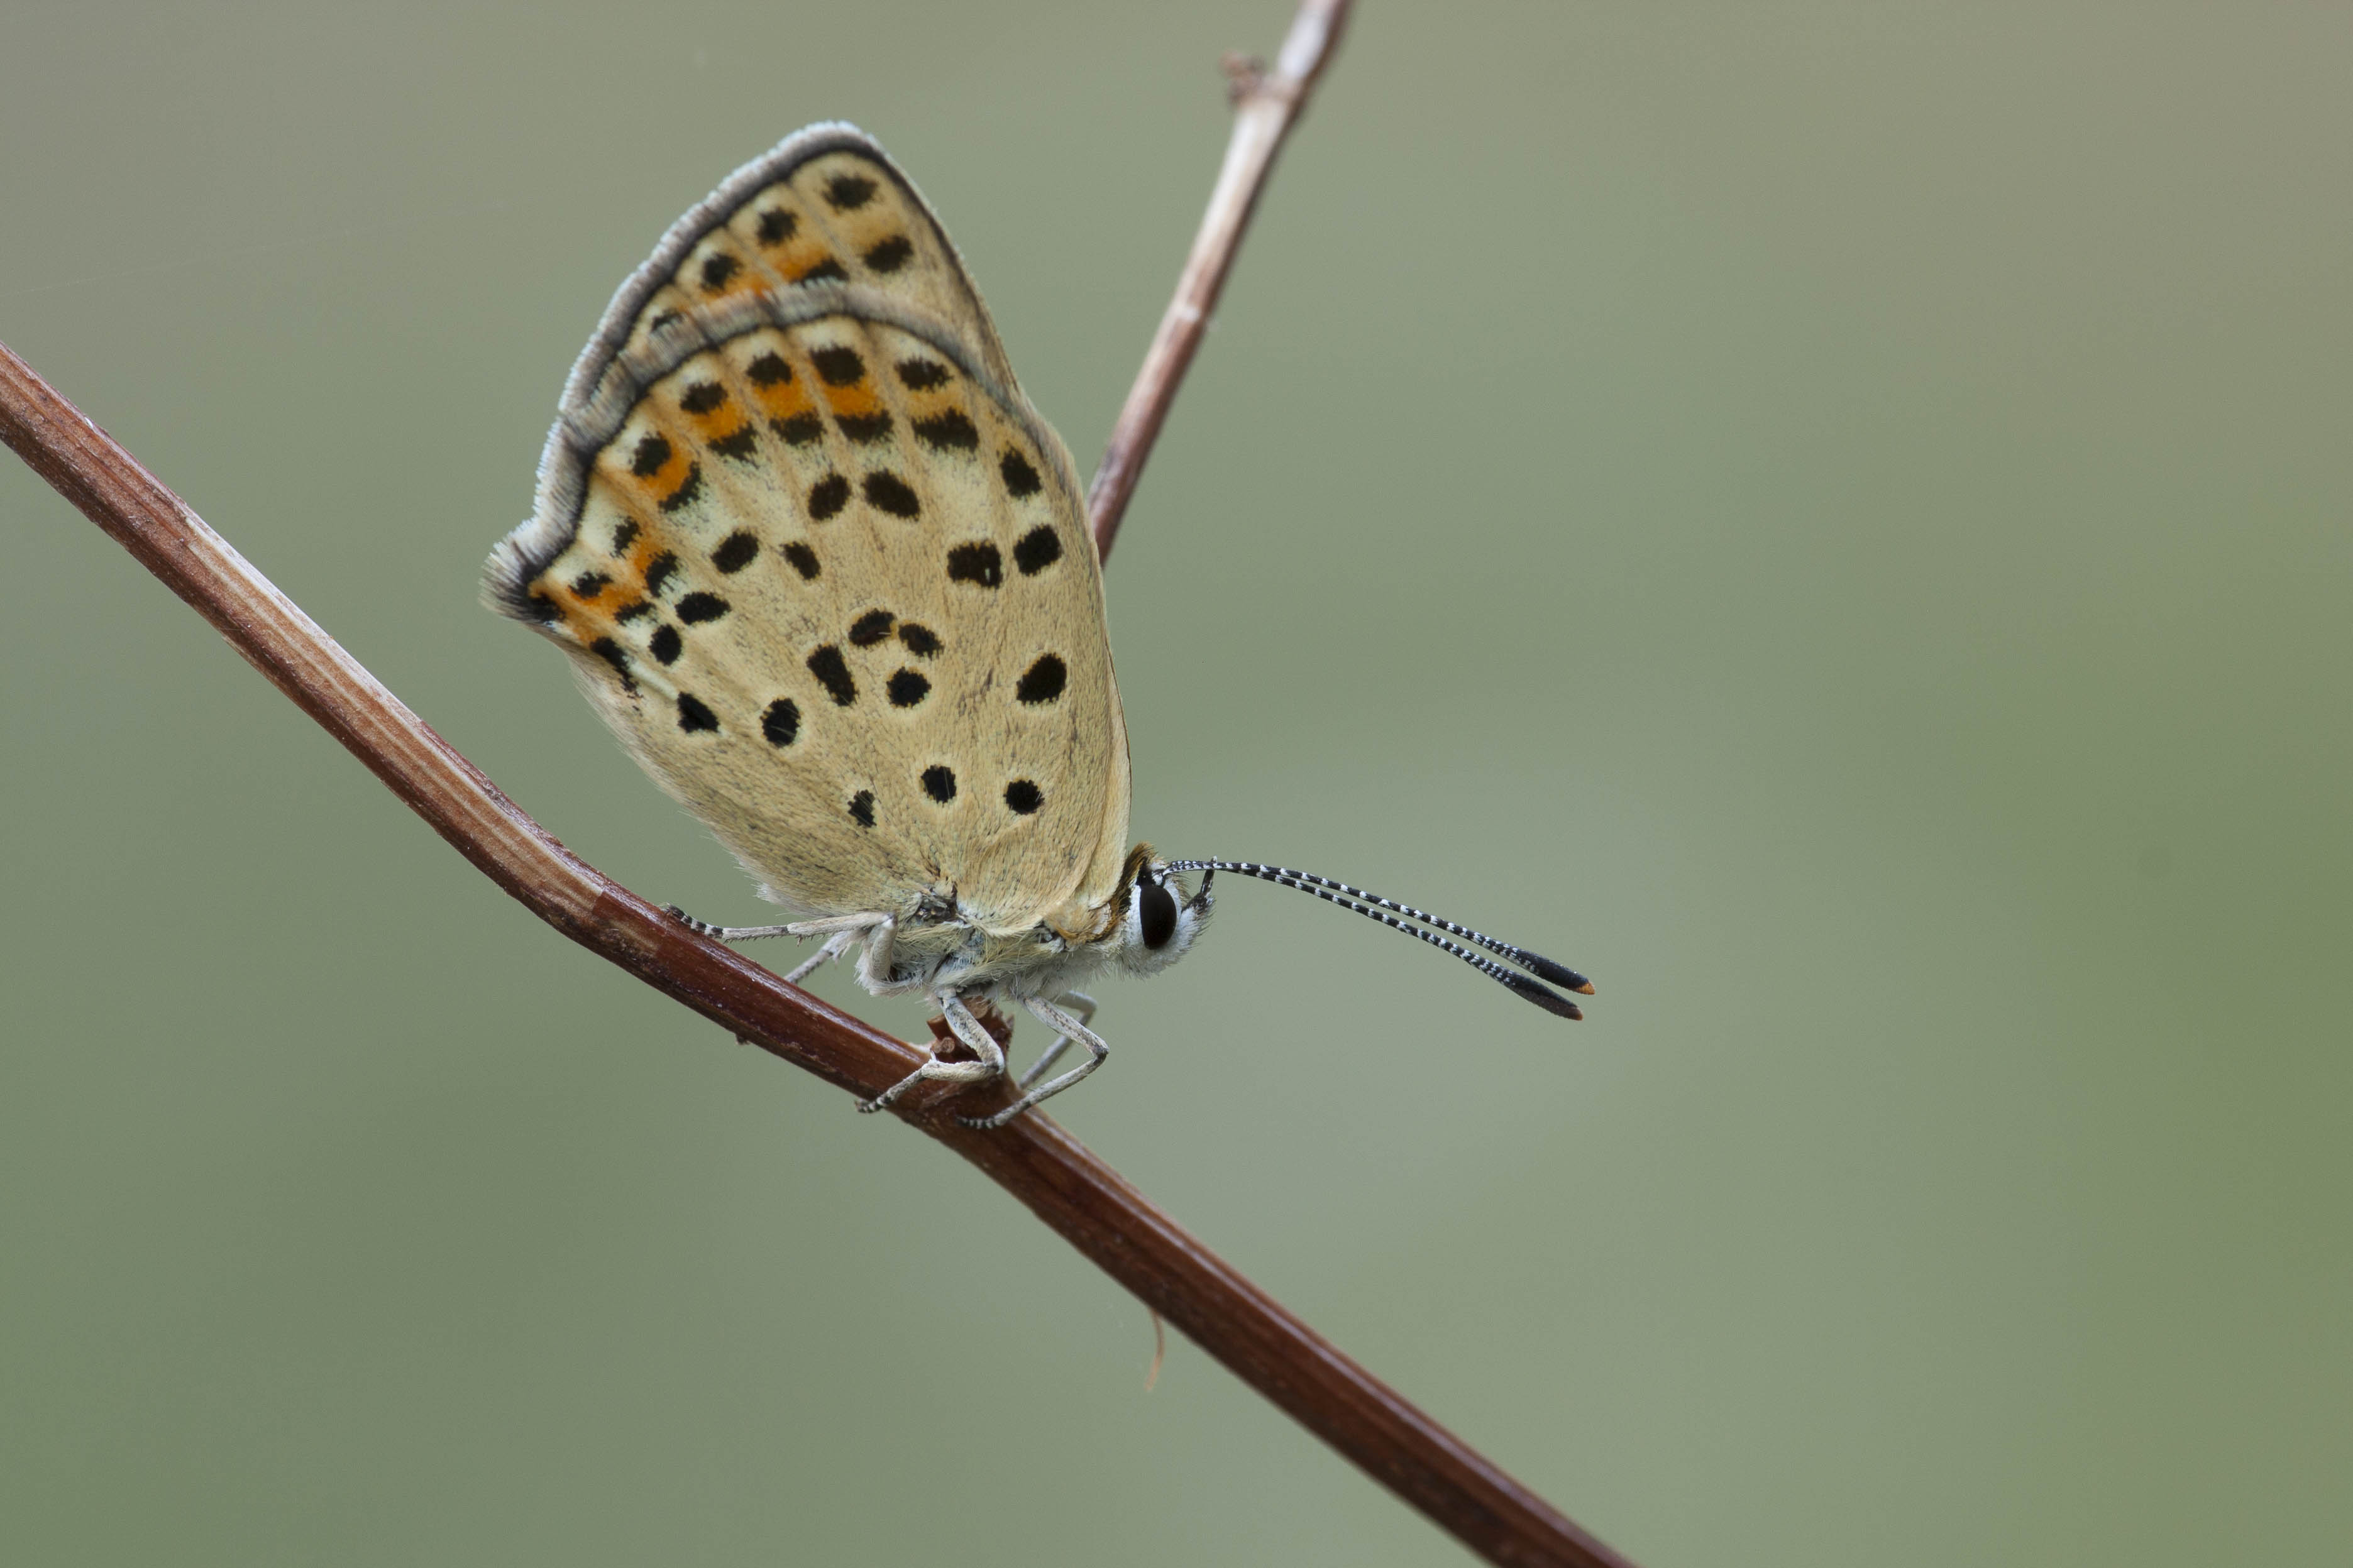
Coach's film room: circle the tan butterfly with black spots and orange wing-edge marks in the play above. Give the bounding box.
[485,123,1590,1126]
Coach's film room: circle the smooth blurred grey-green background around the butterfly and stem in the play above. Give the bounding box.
[0,0,2353,1568]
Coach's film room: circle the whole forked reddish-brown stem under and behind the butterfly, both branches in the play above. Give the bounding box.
[0,0,1626,1568]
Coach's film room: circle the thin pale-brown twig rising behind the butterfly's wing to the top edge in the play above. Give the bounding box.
[1087,0,1350,559]
